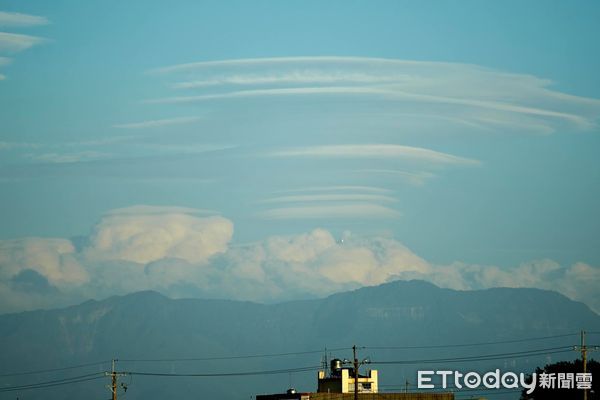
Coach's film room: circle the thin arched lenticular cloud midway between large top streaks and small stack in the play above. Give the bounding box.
[267,144,479,165]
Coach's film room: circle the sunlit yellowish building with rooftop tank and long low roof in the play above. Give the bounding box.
[256,359,454,400]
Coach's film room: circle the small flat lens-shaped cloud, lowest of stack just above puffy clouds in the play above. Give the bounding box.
[257,203,401,219]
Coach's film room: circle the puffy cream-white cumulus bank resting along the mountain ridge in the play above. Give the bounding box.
[0,206,600,312]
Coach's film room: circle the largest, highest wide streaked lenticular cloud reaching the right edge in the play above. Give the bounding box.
[148,56,600,133]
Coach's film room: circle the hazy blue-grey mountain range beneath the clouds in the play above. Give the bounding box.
[0,281,600,400]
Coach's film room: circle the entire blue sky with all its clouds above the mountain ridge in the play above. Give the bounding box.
[0,0,600,312]
